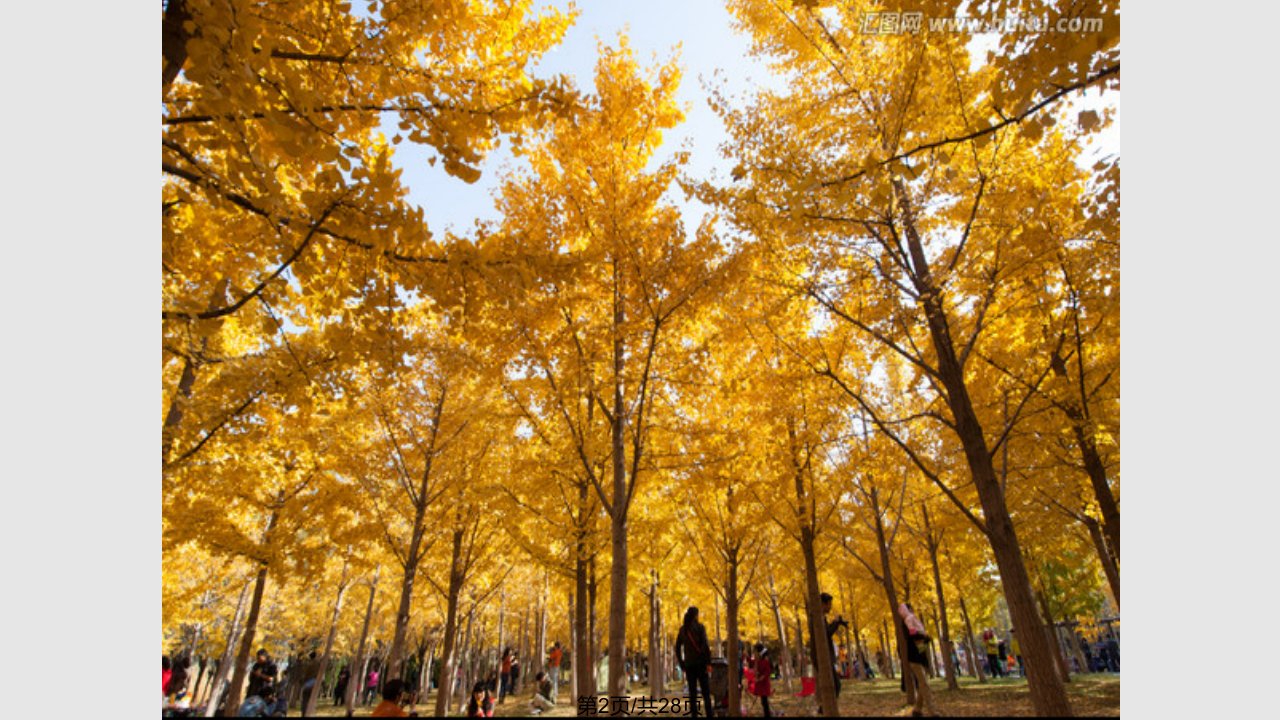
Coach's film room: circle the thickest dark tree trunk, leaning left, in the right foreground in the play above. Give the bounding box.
[893,179,1071,716]
